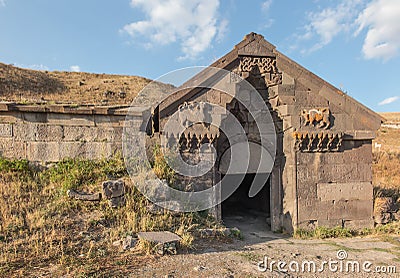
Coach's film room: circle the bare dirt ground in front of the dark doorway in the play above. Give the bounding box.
[129,215,400,277]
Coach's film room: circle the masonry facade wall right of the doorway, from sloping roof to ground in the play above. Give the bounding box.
[270,54,380,229]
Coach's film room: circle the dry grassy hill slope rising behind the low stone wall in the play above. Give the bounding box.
[0,63,174,105]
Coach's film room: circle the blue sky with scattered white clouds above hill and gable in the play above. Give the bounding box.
[0,0,400,112]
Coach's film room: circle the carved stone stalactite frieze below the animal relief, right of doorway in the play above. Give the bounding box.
[293,131,344,152]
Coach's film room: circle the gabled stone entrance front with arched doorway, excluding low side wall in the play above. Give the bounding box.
[153,33,381,231]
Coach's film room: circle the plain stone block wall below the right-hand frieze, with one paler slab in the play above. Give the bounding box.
[297,141,373,228]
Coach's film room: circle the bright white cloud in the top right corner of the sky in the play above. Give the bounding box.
[356,0,400,60]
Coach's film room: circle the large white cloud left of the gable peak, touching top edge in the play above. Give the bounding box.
[122,0,227,59]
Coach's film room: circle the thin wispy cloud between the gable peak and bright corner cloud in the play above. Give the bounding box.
[297,0,363,52]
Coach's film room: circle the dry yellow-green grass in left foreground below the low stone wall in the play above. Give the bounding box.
[0,157,219,277]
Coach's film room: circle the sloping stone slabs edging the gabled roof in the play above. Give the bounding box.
[160,33,384,130]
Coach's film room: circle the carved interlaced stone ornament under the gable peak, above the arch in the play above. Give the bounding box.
[231,56,282,87]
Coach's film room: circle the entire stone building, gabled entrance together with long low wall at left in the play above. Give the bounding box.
[0,33,382,231]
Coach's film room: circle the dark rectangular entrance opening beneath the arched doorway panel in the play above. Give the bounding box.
[221,174,271,229]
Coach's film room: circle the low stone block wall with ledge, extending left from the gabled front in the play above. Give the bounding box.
[0,103,150,162]
